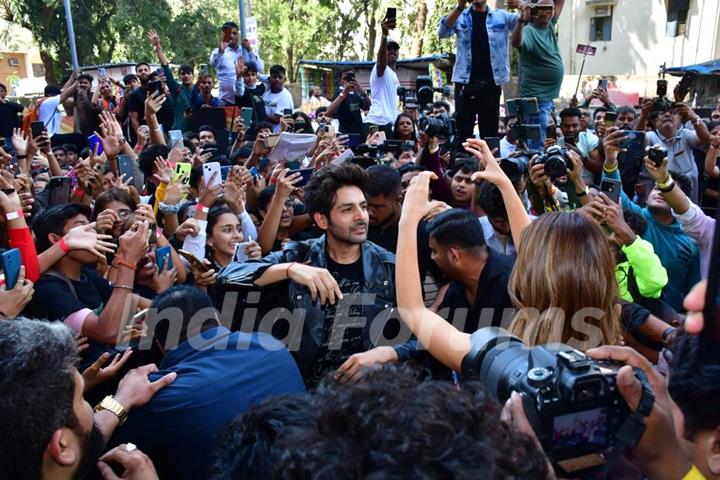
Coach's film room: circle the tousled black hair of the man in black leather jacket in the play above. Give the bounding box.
[305,163,368,219]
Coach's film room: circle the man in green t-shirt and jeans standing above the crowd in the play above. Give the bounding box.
[512,0,565,150]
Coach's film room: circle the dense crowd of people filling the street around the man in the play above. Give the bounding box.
[0,0,720,480]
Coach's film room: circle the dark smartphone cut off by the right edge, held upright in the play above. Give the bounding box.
[699,195,720,363]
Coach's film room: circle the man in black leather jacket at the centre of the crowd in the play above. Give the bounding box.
[218,164,416,387]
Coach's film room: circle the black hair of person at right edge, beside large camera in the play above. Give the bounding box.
[668,331,720,441]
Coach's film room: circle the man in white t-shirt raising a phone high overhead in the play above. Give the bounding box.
[365,15,400,138]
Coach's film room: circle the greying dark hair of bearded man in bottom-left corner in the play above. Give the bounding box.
[0,318,79,479]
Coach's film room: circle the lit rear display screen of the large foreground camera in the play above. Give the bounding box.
[553,407,609,449]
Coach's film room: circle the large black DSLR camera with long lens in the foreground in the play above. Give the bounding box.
[462,327,654,478]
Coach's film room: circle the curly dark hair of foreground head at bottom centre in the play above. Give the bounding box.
[252,367,548,479]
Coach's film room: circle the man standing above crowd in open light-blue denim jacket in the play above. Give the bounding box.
[438,0,522,141]
